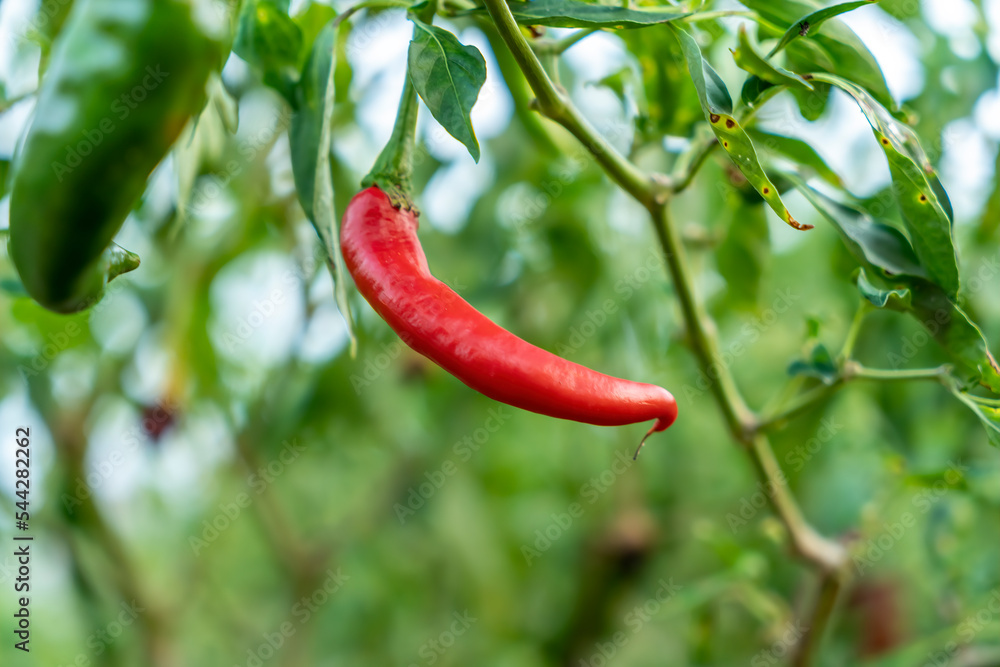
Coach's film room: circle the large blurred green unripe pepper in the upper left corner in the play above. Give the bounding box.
[9,0,220,313]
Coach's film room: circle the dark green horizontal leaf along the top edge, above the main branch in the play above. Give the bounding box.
[509,0,691,28]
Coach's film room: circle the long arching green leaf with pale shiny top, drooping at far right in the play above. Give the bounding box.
[813,73,960,299]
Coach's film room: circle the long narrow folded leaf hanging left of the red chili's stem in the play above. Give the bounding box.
[288,21,357,355]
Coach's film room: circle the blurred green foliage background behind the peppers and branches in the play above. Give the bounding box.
[0,1,1000,667]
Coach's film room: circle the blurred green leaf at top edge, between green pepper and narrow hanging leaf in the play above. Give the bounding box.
[233,0,303,101]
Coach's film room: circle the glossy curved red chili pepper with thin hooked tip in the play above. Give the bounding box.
[340,186,677,446]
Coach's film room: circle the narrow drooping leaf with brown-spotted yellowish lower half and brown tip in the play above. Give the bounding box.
[670,25,812,230]
